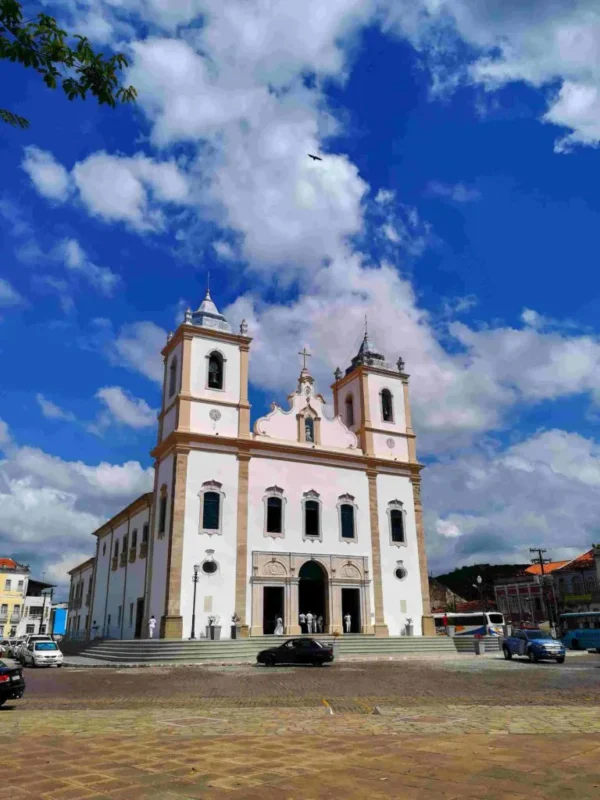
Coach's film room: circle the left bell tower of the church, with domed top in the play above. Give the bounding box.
[158,289,252,444]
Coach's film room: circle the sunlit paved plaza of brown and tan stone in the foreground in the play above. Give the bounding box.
[0,655,600,800]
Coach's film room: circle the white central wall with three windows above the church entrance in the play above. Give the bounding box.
[246,457,374,636]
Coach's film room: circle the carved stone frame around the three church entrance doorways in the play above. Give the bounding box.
[250,551,374,636]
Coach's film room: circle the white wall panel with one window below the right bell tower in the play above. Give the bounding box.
[377,474,423,636]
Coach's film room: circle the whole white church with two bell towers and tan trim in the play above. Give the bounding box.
[69,292,434,639]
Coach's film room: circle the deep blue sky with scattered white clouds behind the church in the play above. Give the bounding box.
[0,0,600,582]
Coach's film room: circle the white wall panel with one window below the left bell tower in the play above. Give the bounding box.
[181,450,238,639]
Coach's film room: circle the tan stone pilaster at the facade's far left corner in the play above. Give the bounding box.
[160,448,189,639]
